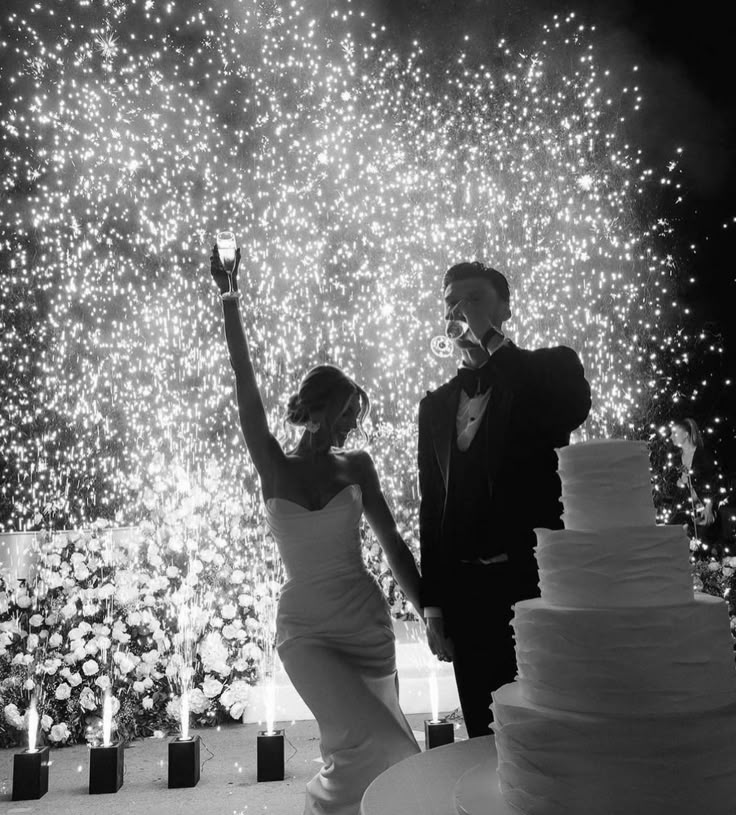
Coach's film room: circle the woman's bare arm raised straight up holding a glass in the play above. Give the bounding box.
[210,244,285,482]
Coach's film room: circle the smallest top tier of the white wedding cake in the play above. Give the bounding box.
[557,439,655,529]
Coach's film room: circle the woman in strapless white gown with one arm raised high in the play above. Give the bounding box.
[210,246,421,815]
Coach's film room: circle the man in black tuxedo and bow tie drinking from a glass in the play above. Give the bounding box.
[418,262,590,738]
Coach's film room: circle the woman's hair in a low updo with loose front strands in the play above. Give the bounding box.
[286,365,371,440]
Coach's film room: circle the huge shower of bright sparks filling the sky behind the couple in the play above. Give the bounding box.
[0,0,696,540]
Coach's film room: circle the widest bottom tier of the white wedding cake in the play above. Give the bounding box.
[493,682,736,815]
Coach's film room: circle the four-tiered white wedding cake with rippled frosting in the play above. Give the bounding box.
[492,441,736,815]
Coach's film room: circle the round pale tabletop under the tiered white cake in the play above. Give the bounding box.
[360,736,518,815]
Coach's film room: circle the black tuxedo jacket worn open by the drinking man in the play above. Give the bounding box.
[418,344,590,607]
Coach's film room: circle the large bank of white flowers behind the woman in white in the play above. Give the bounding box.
[0,457,412,747]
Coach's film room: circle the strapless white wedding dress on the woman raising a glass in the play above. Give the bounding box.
[266,484,419,815]
